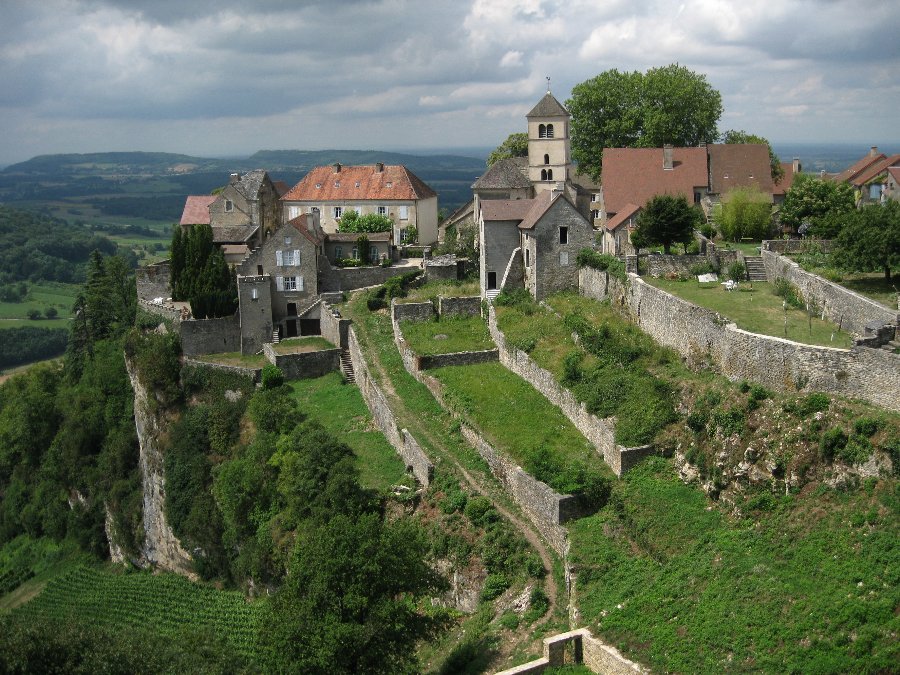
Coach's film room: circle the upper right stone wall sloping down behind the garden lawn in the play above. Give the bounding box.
[762,250,898,335]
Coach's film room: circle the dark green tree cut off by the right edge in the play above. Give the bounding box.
[834,200,900,280]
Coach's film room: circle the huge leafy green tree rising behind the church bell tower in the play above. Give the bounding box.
[566,63,722,179]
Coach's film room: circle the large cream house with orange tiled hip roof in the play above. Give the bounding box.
[281,163,438,245]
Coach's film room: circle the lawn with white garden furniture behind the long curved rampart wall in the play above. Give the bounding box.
[644,277,853,348]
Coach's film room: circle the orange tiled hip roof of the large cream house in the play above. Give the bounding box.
[282,165,437,202]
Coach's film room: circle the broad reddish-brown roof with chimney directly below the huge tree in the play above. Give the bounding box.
[603,148,708,213]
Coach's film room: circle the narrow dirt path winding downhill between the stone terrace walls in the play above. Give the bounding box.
[367,320,559,630]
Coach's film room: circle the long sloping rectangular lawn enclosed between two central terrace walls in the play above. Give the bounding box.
[430,363,609,494]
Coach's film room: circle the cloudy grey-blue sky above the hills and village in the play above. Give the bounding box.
[0,0,900,165]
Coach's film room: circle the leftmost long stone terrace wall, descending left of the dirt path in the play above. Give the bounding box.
[347,326,434,486]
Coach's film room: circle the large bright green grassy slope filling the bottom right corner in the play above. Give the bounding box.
[570,458,900,673]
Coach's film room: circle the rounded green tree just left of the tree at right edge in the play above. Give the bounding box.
[781,173,856,236]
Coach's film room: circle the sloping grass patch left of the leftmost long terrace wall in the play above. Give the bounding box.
[288,373,406,490]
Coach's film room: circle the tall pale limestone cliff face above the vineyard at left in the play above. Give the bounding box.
[125,358,196,578]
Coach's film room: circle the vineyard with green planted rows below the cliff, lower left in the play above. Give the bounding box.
[13,565,264,658]
